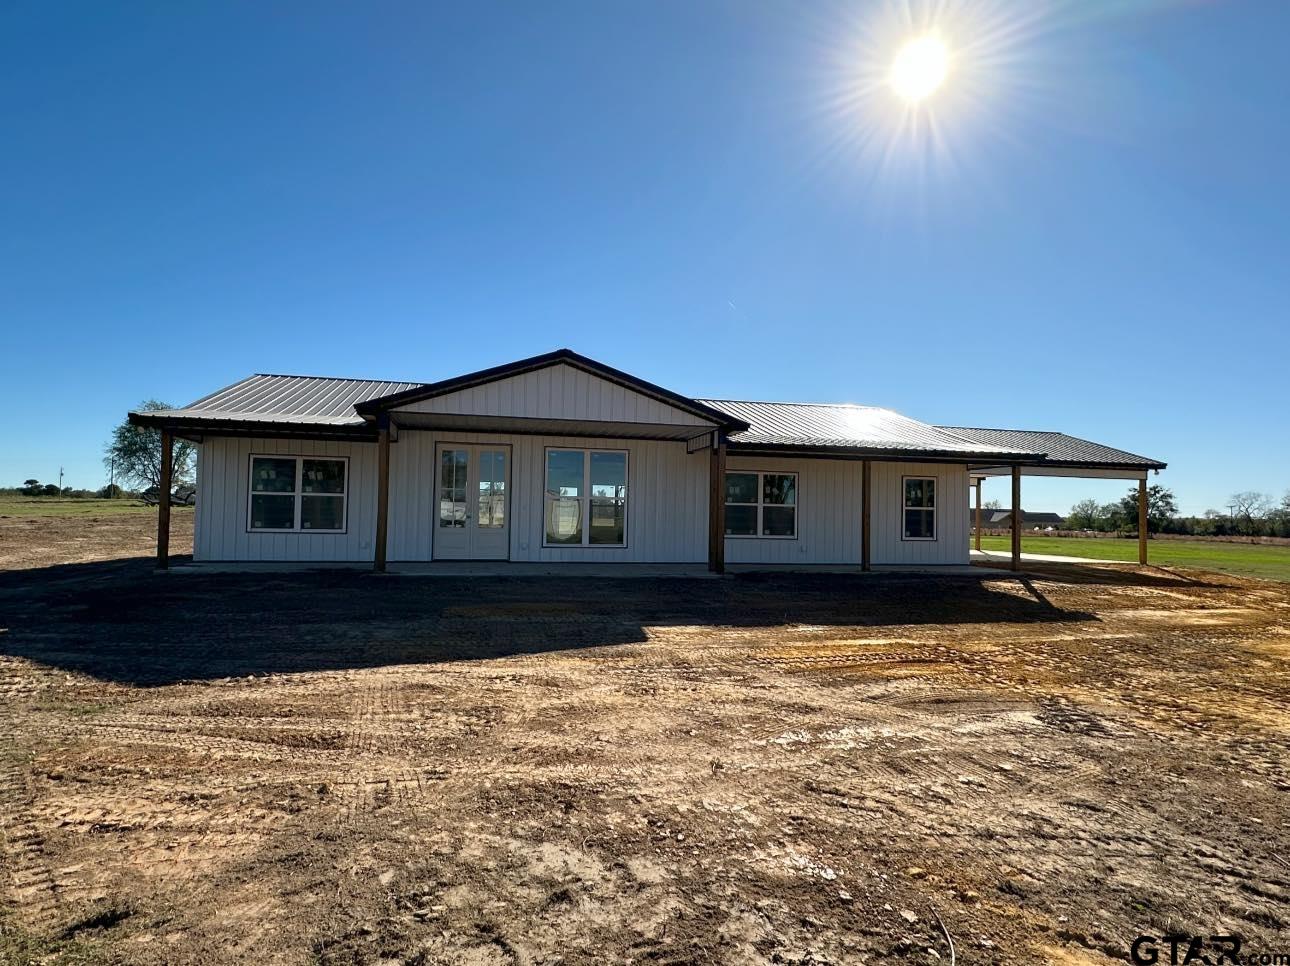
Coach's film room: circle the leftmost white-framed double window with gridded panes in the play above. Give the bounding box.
[246,455,350,534]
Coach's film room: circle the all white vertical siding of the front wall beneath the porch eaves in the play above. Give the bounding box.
[194,435,969,565]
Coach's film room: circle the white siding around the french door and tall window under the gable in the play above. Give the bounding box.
[390,429,708,564]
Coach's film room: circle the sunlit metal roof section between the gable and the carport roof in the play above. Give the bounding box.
[699,399,1044,458]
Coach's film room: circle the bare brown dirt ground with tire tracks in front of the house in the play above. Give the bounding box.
[0,516,1290,965]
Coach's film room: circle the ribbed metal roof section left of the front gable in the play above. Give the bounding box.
[139,373,422,426]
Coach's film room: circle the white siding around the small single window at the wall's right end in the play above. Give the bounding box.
[869,463,969,565]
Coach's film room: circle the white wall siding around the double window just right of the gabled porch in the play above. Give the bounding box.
[726,457,860,564]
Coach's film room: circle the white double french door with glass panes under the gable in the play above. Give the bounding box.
[433,442,511,560]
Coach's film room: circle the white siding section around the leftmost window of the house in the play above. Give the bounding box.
[192,436,377,562]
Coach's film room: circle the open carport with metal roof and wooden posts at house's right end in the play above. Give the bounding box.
[939,426,1166,570]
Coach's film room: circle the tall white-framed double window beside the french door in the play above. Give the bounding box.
[542,446,627,547]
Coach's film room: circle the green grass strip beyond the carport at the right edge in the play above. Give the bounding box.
[980,535,1290,580]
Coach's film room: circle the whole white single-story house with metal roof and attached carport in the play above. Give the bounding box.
[129,350,1165,571]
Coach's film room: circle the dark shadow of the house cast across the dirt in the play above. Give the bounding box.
[0,549,1197,686]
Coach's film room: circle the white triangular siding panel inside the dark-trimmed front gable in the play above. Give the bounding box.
[395,364,710,426]
